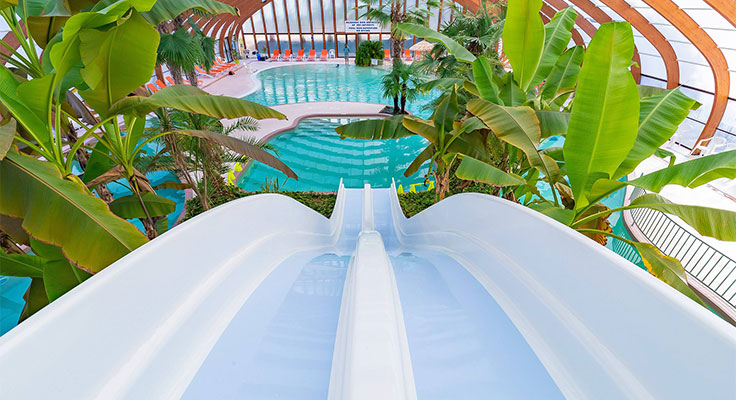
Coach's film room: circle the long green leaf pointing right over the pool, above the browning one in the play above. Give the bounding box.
[110,85,286,119]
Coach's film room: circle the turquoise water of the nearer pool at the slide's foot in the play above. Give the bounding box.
[238,118,428,192]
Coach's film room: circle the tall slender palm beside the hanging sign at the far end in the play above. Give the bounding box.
[356,0,439,60]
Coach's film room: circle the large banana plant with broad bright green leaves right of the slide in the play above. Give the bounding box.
[338,0,736,304]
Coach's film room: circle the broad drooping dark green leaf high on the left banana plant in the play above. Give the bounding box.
[79,11,159,117]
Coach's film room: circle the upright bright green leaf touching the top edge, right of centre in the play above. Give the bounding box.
[503,0,544,91]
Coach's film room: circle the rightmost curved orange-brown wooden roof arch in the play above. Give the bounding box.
[644,0,736,148]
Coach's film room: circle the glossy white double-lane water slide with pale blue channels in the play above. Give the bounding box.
[0,182,736,400]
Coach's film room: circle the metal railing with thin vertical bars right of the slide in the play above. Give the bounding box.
[619,188,736,306]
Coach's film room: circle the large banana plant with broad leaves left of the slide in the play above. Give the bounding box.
[0,0,296,318]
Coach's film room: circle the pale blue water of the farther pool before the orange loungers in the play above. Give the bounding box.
[244,64,439,118]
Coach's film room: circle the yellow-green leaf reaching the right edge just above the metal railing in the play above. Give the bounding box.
[627,193,736,241]
